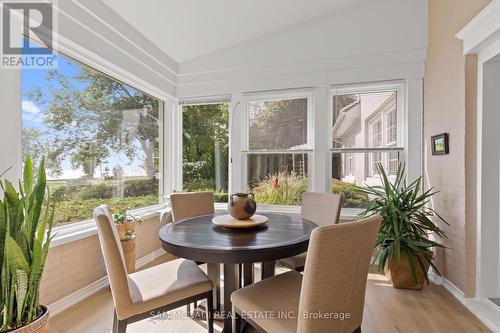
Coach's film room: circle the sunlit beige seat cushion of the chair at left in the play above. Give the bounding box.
[128,259,213,316]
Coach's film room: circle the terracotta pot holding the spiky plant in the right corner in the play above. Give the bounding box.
[384,253,430,290]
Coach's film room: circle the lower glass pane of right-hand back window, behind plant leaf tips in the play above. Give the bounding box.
[332,151,401,208]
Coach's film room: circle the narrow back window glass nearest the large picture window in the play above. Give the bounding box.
[182,103,229,202]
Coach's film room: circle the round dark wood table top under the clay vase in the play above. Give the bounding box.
[160,213,316,263]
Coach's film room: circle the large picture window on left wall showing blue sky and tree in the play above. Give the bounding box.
[22,45,163,225]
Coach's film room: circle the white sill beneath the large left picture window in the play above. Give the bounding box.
[50,204,170,248]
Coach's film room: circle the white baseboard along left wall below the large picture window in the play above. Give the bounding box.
[49,249,165,316]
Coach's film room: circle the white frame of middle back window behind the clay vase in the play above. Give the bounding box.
[238,88,314,208]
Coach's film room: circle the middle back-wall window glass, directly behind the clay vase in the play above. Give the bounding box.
[246,95,310,205]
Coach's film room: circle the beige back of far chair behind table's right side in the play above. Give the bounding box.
[300,192,342,225]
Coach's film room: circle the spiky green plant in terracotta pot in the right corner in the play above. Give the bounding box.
[360,163,448,289]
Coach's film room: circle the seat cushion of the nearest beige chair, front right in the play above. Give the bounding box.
[231,271,302,333]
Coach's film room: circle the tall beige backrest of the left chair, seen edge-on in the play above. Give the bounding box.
[94,205,132,317]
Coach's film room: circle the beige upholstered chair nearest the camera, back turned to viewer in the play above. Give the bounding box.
[231,216,381,333]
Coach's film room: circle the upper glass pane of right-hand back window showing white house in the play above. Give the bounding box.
[332,91,398,148]
